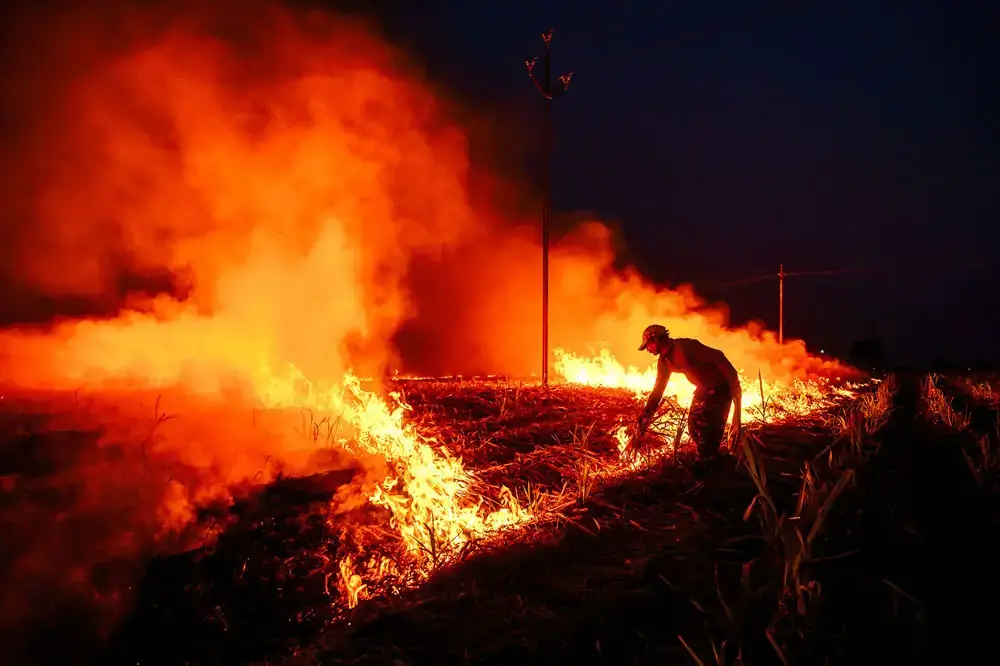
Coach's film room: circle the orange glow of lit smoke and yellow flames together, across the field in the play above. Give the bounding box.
[0,1,860,624]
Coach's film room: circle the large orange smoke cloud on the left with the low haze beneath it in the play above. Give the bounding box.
[0,3,476,652]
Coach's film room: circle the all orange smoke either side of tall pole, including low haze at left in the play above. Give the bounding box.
[0,3,852,652]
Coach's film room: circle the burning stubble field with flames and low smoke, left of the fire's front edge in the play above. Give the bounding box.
[4,370,852,663]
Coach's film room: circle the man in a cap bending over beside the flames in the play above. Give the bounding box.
[633,324,743,460]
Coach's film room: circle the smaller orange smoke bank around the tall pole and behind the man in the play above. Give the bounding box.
[403,221,851,381]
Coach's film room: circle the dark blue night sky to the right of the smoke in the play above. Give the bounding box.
[354,0,1000,359]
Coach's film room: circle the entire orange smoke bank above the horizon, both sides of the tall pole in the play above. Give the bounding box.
[5,5,844,390]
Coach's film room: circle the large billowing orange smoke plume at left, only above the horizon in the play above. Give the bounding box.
[5,2,474,381]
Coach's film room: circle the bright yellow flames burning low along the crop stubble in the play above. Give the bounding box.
[252,354,851,607]
